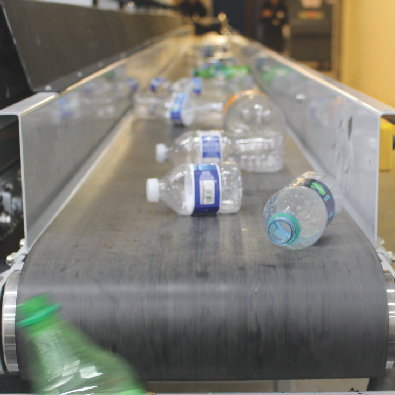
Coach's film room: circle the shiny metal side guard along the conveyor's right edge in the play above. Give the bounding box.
[253,50,395,246]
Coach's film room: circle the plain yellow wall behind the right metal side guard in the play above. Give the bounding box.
[340,0,395,107]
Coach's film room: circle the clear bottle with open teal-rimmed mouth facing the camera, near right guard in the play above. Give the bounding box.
[263,171,343,250]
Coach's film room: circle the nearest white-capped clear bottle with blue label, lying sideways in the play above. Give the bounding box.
[147,163,243,215]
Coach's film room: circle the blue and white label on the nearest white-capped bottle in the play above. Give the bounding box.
[191,164,221,214]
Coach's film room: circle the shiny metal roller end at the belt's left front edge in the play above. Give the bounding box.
[1,271,21,373]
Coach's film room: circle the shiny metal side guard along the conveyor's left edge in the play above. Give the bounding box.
[0,29,190,250]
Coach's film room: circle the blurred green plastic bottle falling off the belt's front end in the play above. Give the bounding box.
[17,295,144,395]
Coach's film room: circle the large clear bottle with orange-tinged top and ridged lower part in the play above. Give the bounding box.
[224,90,286,172]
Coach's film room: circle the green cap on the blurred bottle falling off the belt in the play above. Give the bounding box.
[16,294,60,328]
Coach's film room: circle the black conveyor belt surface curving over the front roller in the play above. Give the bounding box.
[17,55,389,381]
